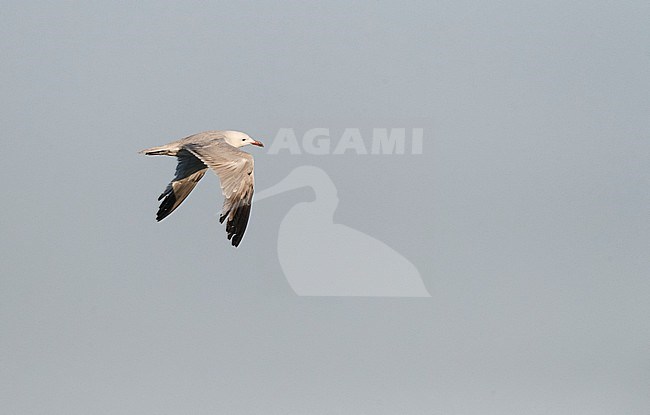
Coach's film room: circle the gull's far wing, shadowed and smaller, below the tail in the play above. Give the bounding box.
[156,150,208,221]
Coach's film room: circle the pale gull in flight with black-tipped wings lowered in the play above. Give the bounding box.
[140,131,264,247]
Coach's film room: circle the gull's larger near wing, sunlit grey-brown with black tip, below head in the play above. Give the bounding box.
[185,141,255,246]
